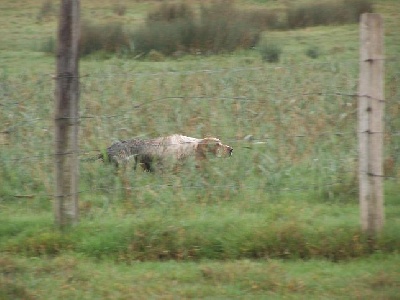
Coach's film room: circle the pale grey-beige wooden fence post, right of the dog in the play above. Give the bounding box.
[358,13,385,238]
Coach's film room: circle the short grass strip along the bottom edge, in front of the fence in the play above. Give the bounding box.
[0,254,400,299]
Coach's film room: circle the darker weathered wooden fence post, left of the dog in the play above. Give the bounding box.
[54,0,80,228]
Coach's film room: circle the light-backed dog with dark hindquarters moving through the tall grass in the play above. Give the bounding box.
[98,134,233,172]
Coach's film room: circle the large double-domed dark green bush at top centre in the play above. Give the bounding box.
[133,1,260,55]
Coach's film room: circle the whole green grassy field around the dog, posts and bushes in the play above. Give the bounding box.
[0,0,400,299]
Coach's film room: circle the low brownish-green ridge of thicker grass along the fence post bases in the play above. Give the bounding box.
[0,211,399,262]
